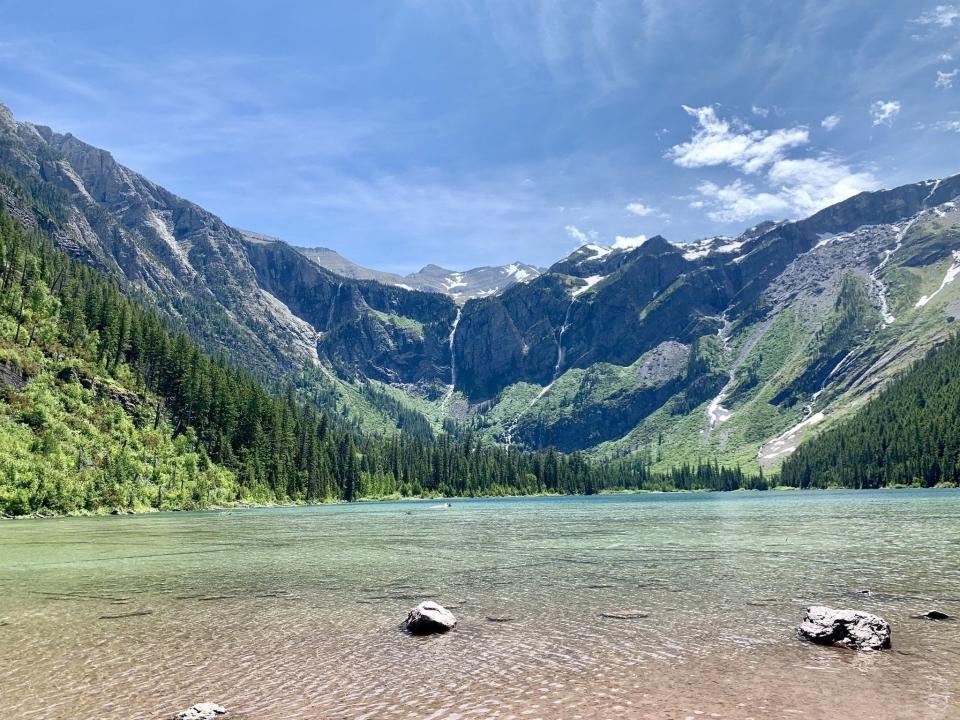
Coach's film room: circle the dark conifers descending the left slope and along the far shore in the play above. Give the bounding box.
[0,200,764,512]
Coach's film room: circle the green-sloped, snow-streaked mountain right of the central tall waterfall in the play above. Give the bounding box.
[455,177,960,469]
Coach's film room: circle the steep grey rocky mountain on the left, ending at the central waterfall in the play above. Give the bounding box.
[0,105,457,429]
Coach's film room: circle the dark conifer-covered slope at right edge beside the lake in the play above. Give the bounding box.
[780,335,960,488]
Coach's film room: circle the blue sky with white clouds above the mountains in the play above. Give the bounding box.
[0,0,960,272]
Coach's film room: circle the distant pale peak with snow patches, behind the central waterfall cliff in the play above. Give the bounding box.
[284,239,543,304]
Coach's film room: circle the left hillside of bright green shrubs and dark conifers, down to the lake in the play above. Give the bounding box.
[0,200,749,515]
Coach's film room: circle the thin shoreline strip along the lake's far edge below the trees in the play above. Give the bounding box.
[0,483,960,520]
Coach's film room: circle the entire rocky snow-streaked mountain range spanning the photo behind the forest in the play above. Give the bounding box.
[0,100,960,470]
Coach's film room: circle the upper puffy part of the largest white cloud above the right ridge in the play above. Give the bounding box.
[666,105,810,173]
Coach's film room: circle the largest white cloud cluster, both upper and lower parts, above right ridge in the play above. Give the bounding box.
[668,107,878,222]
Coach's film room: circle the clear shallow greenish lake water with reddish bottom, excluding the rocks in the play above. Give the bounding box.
[0,491,960,720]
